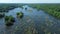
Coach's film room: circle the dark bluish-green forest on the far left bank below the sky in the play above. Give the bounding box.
[0,4,23,12]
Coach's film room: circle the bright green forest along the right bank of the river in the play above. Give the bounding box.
[30,4,60,18]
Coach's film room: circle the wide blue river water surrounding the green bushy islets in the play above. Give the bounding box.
[0,7,60,34]
